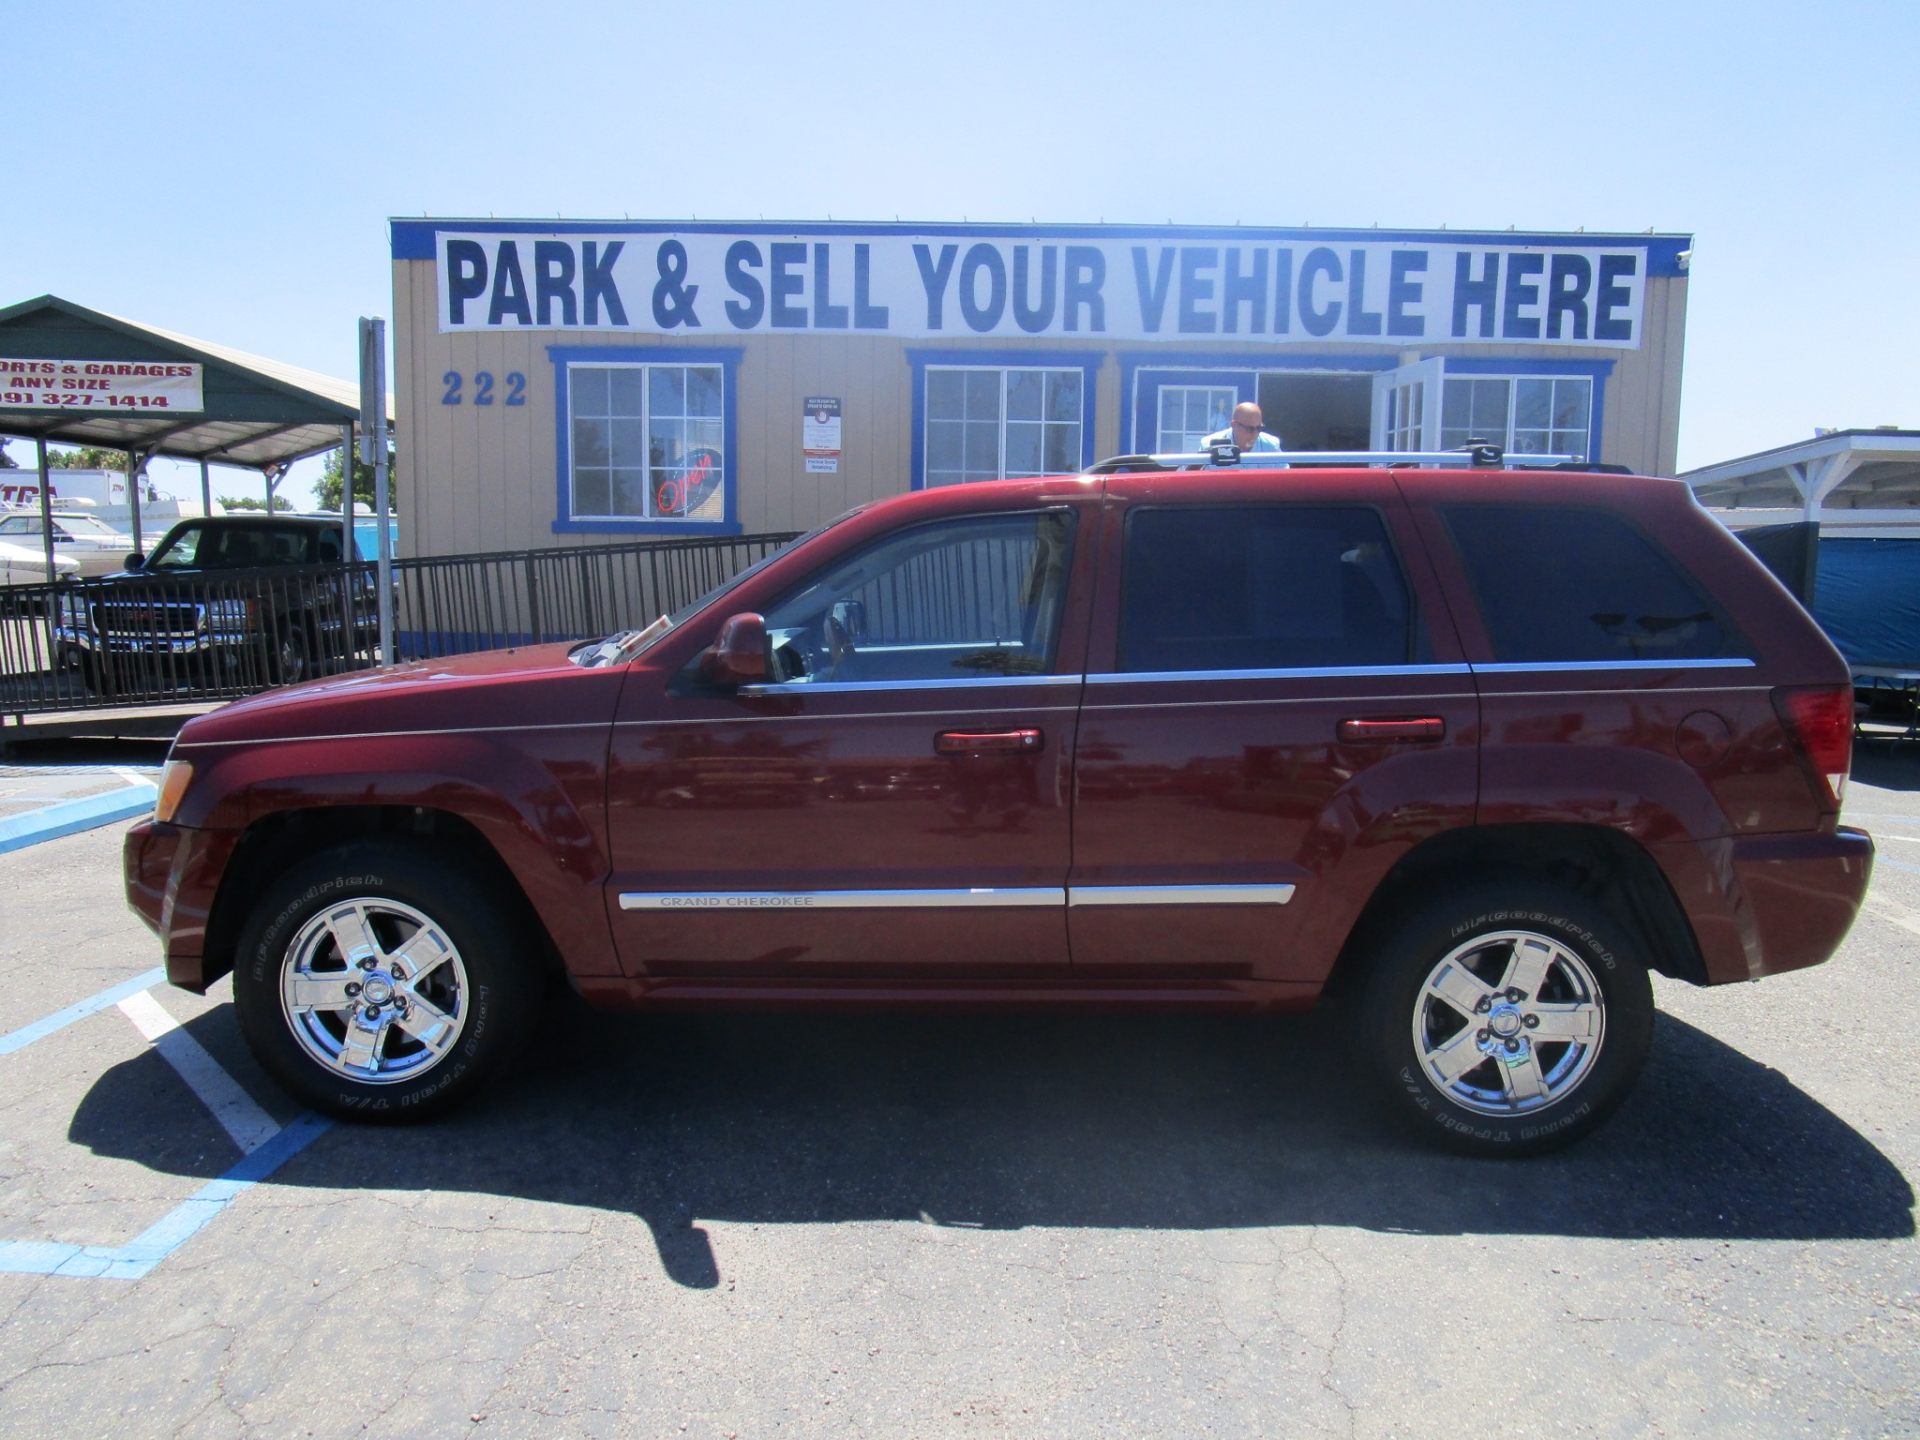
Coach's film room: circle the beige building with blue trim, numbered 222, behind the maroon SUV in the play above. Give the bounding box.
[392,219,1690,555]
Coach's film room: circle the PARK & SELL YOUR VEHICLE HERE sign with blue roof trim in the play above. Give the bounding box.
[408,221,1686,349]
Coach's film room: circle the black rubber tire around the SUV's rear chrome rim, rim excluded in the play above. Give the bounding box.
[1359,879,1653,1158]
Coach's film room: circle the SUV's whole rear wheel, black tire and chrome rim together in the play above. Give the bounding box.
[1356,877,1653,1156]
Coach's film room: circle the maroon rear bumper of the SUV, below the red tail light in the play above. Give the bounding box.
[1655,826,1874,985]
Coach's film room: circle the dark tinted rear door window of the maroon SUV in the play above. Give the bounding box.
[1119,505,1415,670]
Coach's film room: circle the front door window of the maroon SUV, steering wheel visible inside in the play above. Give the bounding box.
[766,509,1073,684]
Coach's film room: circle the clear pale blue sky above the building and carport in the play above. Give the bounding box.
[0,0,1920,510]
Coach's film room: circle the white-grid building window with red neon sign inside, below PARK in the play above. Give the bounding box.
[566,365,726,522]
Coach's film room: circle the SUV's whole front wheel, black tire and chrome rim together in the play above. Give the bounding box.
[234,841,540,1123]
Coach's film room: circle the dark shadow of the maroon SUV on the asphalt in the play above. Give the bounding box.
[69,1006,1914,1286]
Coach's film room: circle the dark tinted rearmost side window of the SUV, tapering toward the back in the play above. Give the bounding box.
[1444,505,1743,662]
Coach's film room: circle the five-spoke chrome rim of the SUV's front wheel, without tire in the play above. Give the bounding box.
[280,897,468,1085]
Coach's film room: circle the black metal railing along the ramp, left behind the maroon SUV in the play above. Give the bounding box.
[0,534,795,714]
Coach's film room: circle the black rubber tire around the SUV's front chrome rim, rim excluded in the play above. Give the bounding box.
[234,841,538,1123]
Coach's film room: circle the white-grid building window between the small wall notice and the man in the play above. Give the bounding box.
[925,365,1085,486]
